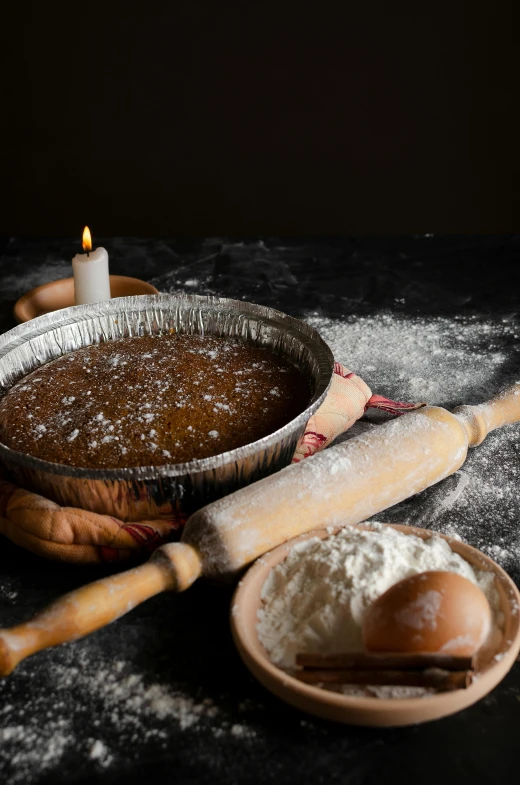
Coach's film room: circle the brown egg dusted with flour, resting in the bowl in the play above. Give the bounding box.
[363,571,492,656]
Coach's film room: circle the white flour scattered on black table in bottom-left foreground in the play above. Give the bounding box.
[0,642,256,785]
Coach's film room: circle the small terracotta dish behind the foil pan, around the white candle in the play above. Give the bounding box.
[13,275,159,324]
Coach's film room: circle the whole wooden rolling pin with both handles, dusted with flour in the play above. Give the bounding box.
[0,382,520,676]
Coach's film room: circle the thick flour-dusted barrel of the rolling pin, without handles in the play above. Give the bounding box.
[183,407,468,576]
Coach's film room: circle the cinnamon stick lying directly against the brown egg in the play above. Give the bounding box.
[296,652,475,671]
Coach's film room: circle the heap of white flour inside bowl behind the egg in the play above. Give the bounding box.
[257,523,498,668]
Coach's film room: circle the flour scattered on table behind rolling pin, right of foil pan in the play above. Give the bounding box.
[306,313,520,406]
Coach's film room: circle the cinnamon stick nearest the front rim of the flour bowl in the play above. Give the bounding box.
[294,668,473,692]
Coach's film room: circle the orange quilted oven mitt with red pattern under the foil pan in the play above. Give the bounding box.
[0,363,425,564]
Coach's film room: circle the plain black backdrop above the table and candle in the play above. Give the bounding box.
[0,0,520,237]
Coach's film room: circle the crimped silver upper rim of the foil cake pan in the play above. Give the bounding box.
[0,293,334,481]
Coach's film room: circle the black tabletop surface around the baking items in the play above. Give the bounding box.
[0,236,520,785]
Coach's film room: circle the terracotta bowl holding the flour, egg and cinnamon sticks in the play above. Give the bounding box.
[231,524,520,727]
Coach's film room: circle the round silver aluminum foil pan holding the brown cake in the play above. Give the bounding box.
[0,294,334,521]
